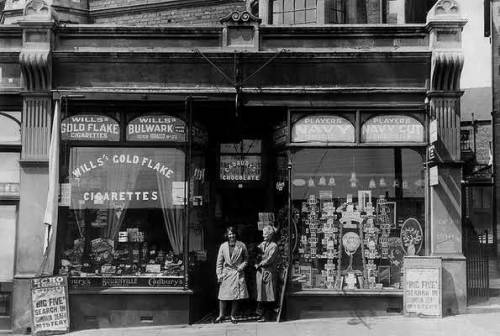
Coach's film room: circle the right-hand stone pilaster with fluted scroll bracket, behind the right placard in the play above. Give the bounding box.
[427,0,467,315]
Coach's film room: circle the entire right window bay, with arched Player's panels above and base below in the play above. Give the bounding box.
[287,110,428,318]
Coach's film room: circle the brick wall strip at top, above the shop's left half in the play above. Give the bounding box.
[90,0,246,26]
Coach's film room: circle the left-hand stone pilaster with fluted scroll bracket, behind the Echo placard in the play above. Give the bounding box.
[12,7,55,333]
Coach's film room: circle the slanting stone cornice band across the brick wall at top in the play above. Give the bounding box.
[89,0,243,18]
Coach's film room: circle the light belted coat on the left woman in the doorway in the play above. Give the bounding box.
[216,241,248,300]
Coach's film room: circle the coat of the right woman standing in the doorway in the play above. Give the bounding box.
[256,242,278,302]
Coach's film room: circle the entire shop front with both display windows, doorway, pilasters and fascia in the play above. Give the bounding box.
[0,1,466,332]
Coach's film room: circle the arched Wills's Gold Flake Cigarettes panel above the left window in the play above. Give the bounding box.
[61,114,120,141]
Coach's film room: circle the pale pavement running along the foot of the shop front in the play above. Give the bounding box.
[63,297,500,336]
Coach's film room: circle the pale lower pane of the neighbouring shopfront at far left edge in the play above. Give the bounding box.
[0,205,17,281]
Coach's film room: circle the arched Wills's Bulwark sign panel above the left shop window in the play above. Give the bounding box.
[126,115,186,142]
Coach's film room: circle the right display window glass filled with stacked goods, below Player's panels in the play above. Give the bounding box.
[291,148,425,290]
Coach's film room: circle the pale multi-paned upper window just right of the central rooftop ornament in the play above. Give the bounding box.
[272,0,318,24]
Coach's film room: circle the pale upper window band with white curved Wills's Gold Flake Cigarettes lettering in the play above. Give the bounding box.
[70,147,185,210]
